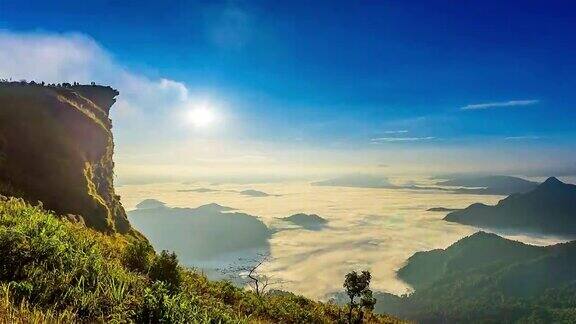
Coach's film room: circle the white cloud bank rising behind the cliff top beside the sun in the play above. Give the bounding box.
[0,30,219,138]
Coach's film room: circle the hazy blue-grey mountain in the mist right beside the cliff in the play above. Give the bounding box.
[128,200,272,265]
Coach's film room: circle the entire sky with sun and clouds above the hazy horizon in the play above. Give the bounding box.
[0,0,576,180]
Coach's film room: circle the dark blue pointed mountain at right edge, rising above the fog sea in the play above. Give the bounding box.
[444,177,576,235]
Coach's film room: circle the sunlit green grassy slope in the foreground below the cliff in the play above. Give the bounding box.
[0,197,400,323]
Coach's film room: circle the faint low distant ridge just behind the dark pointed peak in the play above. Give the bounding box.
[436,175,538,195]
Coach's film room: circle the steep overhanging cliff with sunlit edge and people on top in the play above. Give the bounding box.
[0,83,131,233]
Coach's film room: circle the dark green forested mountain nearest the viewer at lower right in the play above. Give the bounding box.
[376,232,576,323]
